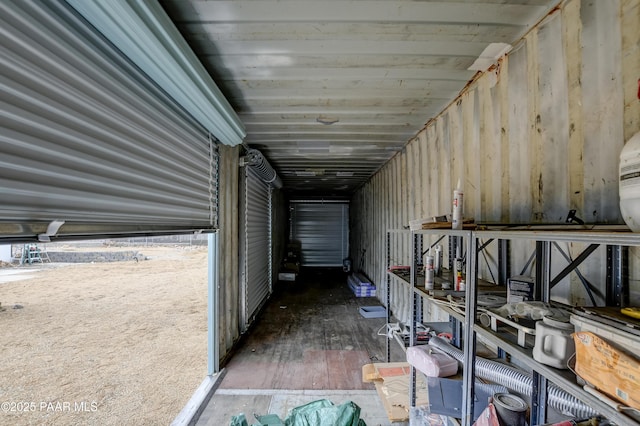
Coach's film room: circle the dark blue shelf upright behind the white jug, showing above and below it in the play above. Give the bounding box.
[529,241,551,425]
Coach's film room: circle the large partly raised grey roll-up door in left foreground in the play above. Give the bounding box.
[0,1,217,241]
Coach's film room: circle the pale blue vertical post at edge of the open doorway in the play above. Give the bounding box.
[207,231,220,376]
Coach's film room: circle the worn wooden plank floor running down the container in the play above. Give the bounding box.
[220,268,404,390]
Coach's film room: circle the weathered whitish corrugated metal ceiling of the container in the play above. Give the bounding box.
[160,0,558,196]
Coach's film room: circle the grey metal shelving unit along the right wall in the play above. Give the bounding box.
[387,226,640,425]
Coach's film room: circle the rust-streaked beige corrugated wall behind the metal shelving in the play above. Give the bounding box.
[351,0,640,319]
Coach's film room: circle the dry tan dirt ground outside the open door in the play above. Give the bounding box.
[0,247,207,425]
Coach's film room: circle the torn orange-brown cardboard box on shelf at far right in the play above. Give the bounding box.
[573,331,640,409]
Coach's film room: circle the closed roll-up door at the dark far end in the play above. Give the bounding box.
[289,201,349,266]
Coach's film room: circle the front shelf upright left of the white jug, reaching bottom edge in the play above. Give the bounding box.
[462,232,478,425]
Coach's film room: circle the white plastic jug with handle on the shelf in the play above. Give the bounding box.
[533,316,576,369]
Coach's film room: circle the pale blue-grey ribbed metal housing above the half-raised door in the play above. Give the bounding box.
[67,0,246,146]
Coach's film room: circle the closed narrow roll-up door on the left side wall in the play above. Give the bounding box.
[240,166,272,326]
